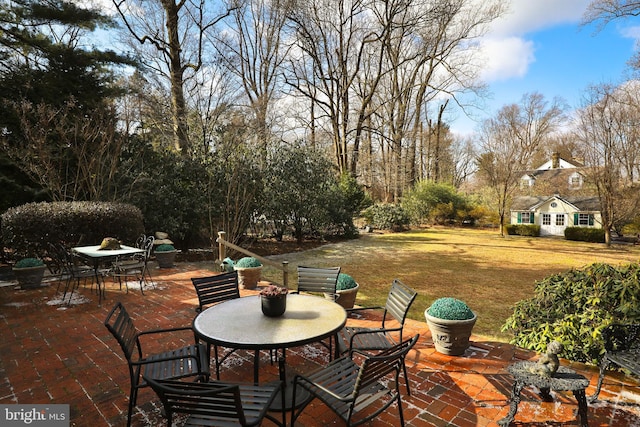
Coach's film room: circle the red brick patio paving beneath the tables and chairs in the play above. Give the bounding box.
[0,263,640,427]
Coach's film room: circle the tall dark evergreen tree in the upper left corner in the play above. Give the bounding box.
[0,0,132,210]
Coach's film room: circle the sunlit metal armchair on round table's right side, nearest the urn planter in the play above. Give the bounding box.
[336,279,418,395]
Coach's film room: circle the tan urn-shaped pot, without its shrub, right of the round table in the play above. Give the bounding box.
[424,308,478,356]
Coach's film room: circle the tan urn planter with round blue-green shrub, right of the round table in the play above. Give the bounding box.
[424,297,477,356]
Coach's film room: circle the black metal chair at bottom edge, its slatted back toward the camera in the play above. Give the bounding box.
[145,378,286,427]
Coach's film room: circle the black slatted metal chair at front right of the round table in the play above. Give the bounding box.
[291,335,419,426]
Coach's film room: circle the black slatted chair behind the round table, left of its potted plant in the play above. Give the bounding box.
[191,271,240,379]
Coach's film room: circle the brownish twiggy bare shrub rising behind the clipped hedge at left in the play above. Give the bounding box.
[0,101,125,201]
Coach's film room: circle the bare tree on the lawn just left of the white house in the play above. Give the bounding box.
[478,93,564,236]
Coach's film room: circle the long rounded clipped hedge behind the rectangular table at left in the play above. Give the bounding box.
[2,202,144,255]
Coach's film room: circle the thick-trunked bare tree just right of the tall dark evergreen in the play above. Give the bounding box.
[112,0,235,152]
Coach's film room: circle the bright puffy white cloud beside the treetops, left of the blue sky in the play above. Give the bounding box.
[480,37,535,82]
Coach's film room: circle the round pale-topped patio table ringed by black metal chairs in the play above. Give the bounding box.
[193,294,347,410]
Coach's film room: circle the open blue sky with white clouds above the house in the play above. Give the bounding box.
[450,0,640,135]
